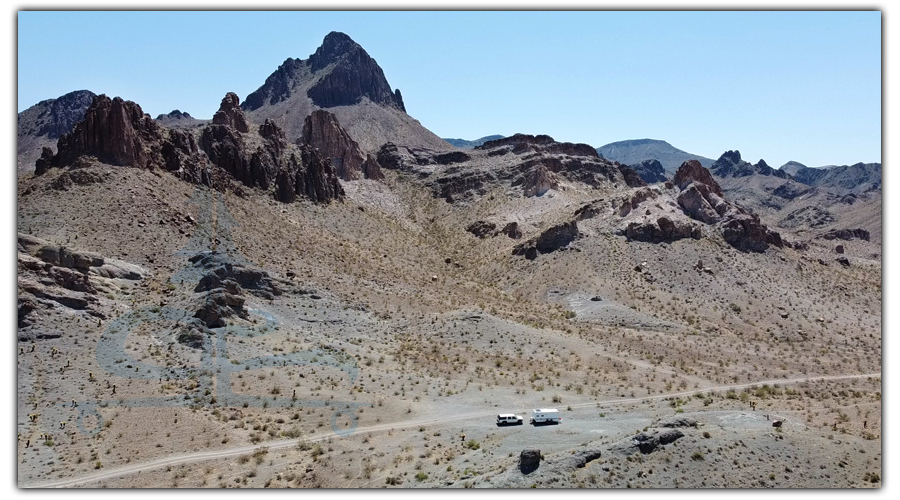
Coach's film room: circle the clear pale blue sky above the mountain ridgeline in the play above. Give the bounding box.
[18,11,882,167]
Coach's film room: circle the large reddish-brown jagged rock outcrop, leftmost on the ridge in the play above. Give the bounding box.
[42,95,162,170]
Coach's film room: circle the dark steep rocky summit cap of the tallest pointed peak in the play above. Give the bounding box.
[307,31,406,112]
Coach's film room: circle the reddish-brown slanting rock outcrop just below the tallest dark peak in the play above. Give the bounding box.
[301,109,384,181]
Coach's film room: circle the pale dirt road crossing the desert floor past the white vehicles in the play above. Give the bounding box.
[26,372,881,488]
